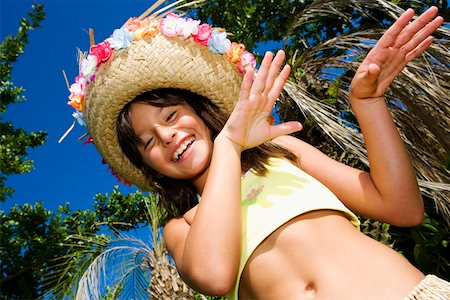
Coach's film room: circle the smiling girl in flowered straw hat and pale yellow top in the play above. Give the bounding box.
[67,3,450,299]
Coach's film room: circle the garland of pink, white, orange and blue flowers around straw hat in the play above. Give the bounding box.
[63,13,256,185]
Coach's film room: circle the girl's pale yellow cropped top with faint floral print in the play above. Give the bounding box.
[228,158,360,299]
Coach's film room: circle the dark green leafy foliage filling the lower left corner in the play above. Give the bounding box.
[0,187,158,299]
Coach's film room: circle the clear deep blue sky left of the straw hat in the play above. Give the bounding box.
[0,0,164,211]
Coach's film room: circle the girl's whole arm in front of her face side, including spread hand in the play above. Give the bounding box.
[164,51,301,295]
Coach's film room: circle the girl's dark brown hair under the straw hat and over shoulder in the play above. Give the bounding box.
[117,89,296,218]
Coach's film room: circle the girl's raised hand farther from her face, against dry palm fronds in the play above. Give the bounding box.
[350,7,443,101]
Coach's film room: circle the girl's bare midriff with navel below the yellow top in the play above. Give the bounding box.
[239,210,424,300]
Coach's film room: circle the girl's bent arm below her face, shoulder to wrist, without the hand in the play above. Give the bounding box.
[164,136,241,295]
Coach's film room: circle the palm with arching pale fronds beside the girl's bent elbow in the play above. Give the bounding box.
[47,195,204,300]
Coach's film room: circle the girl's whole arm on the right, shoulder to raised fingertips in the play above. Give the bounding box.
[278,7,443,226]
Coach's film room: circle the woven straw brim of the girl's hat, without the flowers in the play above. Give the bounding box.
[85,34,242,190]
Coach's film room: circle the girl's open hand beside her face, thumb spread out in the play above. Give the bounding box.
[221,51,302,150]
